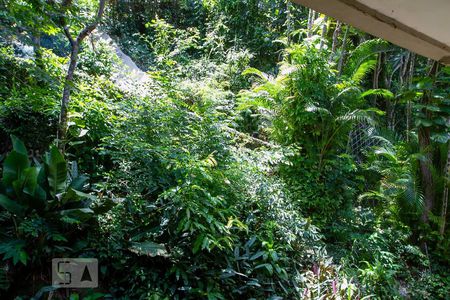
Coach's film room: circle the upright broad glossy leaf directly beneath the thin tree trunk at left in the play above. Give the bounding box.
[45,146,67,198]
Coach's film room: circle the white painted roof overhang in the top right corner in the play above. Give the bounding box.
[292,0,450,65]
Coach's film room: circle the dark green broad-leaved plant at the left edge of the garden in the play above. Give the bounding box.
[0,136,111,293]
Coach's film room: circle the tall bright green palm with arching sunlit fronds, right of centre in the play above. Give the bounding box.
[239,44,384,167]
